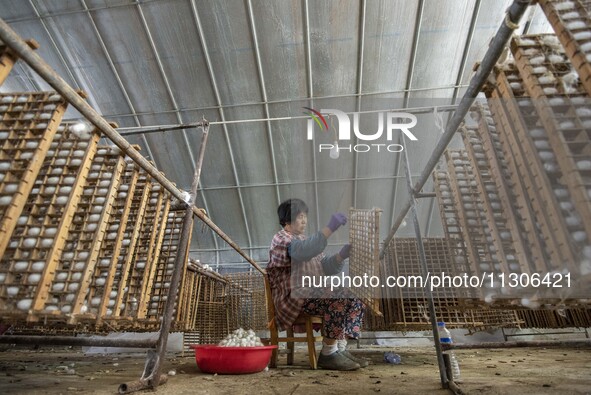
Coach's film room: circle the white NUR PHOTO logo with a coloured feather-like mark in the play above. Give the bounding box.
[304,107,418,159]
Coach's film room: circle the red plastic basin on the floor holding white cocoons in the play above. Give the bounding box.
[190,344,277,374]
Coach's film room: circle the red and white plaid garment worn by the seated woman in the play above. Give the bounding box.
[267,230,326,329]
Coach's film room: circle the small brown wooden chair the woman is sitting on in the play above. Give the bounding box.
[265,275,323,369]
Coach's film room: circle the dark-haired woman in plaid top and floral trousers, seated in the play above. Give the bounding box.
[267,199,368,370]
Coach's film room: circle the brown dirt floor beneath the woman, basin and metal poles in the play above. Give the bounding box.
[0,346,591,395]
